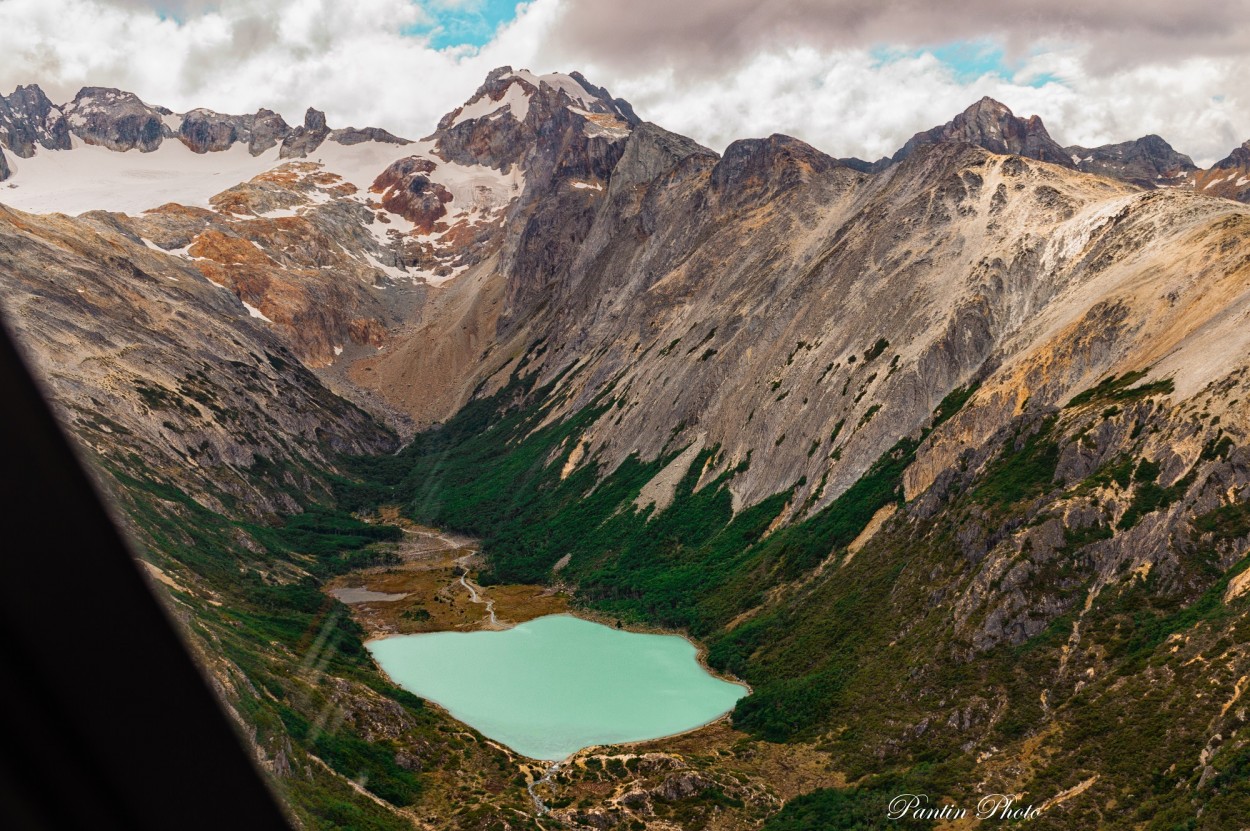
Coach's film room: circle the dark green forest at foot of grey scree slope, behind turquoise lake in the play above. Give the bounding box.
[341,367,971,740]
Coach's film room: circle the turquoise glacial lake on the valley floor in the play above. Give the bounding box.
[366,615,746,760]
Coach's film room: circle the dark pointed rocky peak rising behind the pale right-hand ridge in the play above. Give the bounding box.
[890,96,1075,167]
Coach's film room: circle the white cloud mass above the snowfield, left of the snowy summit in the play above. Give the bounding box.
[0,0,560,137]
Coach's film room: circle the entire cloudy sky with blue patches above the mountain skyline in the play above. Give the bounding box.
[0,0,1250,164]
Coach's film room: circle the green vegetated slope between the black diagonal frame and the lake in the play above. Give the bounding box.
[98,460,525,831]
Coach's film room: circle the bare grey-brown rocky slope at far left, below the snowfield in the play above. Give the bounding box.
[0,202,394,514]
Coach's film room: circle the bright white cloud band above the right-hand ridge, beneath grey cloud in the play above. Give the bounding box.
[575,46,1250,164]
